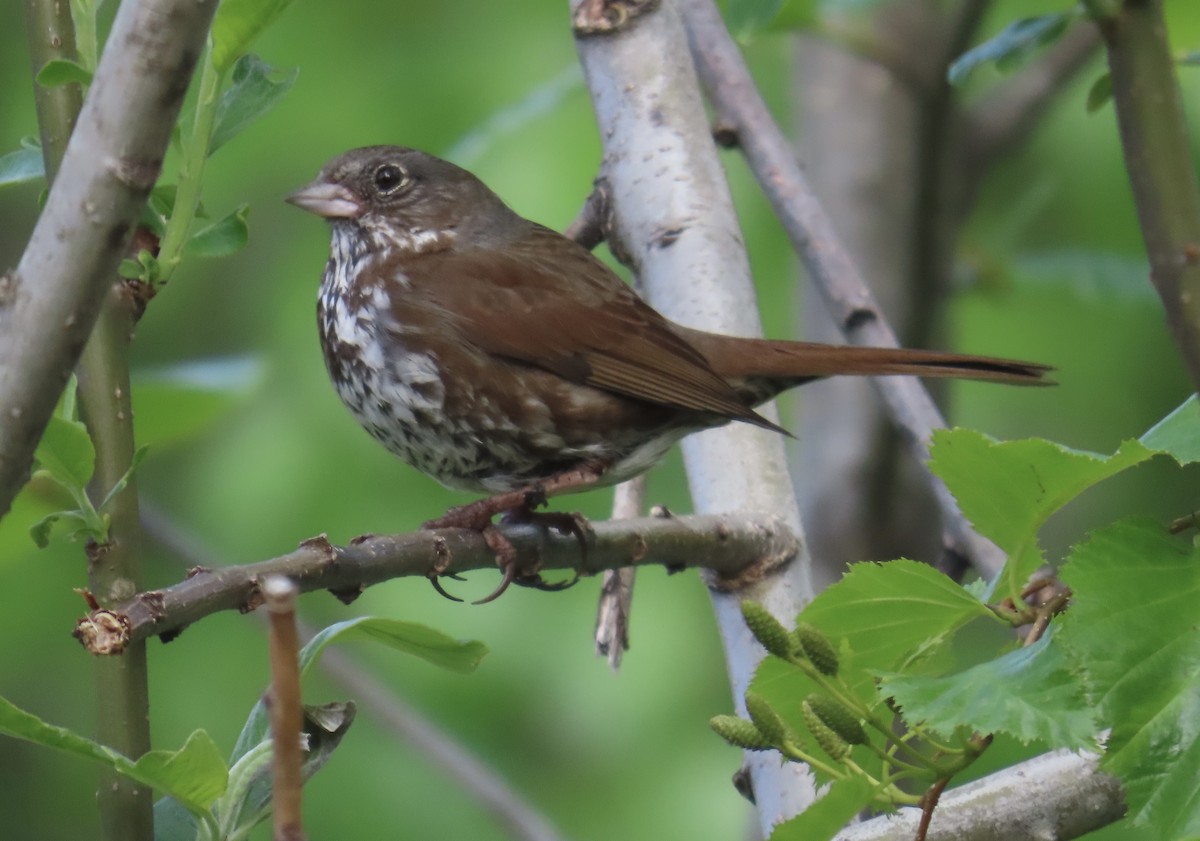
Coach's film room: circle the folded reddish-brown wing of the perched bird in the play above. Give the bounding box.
[403,226,782,431]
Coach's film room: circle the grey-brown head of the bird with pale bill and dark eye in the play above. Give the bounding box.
[288,146,529,253]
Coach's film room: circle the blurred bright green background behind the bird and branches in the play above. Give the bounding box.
[0,0,1200,840]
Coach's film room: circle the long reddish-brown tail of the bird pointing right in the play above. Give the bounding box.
[682,329,1052,388]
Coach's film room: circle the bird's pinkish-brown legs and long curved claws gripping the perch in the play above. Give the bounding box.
[421,463,606,605]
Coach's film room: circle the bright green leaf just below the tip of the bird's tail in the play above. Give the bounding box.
[929,429,1153,584]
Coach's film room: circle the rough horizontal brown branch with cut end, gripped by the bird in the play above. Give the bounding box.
[76,515,798,654]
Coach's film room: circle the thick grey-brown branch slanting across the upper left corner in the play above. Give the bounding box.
[0,0,217,515]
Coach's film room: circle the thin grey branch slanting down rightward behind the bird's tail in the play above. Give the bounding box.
[682,0,1004,577]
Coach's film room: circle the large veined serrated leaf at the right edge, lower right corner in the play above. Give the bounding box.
[1058,519,1200,839]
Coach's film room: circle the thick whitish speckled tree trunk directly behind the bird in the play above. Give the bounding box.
[572,0,816,835]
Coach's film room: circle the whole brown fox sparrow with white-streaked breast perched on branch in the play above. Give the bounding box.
[288,146,1048,597]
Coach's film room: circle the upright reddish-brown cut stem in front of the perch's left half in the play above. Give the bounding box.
[263,576,306,841]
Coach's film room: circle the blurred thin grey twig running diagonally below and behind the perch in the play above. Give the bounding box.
[142,503,563,841]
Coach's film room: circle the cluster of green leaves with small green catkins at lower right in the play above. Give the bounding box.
[722,396,1200,839]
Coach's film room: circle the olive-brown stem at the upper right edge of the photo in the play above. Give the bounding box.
[1087,0,1200,390]
